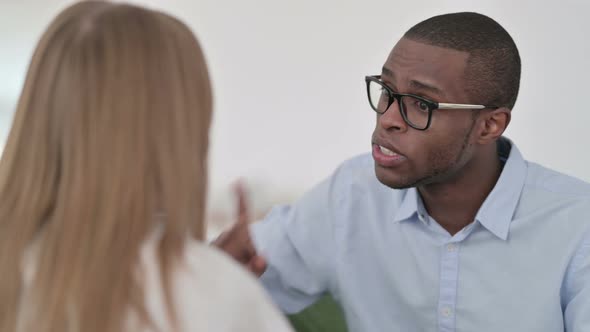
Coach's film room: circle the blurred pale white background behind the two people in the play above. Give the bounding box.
[0,0,590,236]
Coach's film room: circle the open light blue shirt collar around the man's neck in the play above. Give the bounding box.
[393,137,526,240]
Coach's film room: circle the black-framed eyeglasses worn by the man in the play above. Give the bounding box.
[365,75,498,130]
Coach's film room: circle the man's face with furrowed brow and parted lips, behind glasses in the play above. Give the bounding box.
[372,38,486,188]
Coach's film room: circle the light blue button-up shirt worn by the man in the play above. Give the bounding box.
[252,141,590,332]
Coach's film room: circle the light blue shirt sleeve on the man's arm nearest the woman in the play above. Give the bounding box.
[251,176,338,314]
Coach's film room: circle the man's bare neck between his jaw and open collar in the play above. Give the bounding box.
[418,145,502,235]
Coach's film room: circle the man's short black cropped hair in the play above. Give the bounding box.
[404,12,521,109]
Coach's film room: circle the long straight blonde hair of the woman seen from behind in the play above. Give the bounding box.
[0,1,212,332]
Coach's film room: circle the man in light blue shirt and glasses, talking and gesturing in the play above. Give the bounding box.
[217,13,590,332]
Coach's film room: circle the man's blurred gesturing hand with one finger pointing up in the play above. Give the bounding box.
[213,183,266,277]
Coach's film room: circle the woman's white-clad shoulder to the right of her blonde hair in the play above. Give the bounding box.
[147,240,291,332]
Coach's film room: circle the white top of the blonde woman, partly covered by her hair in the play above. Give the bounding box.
[21,236,293,332]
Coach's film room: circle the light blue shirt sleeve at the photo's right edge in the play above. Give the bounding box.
[563,232,590,332]
